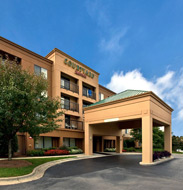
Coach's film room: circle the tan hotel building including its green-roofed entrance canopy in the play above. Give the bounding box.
[0,37,173,164]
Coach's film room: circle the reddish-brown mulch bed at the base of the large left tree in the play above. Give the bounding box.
[0,160,32,168]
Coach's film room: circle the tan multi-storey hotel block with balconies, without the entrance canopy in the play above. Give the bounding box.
[0,37,126,155]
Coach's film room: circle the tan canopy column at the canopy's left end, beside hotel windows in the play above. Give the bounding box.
[85,123,93,155]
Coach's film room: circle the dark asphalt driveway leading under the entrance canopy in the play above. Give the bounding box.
[0,155,183,190]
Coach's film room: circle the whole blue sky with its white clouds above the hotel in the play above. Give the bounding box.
[0,0,183,135]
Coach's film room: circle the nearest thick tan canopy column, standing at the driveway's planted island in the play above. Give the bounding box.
[140,116,153,164]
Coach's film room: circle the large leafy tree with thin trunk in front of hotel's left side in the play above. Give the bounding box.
[0,62,62,160]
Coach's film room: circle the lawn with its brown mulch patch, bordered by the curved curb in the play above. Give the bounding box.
[0,156,75,177]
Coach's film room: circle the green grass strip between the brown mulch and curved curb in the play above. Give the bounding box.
[0,156,76,177]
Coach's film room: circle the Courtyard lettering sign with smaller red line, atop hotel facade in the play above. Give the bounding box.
[64,59,94,79]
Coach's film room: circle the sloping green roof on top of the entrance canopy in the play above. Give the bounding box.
[88,90,148,107]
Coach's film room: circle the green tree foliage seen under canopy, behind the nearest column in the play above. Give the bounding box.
[130,127,164,148]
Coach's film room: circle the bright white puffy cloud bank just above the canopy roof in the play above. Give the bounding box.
[106,69,183,121]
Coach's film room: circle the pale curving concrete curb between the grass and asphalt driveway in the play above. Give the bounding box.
[0,155,107,186]
